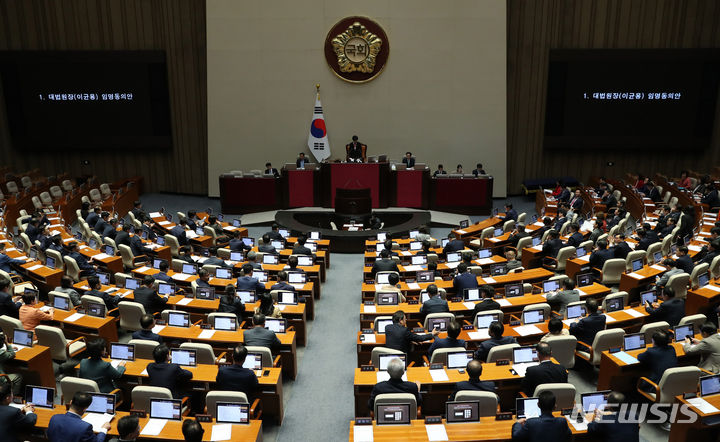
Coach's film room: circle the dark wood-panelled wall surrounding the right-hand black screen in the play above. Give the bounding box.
[507,0,720,193]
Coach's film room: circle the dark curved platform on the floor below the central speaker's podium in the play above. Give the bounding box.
[275,210,430,253]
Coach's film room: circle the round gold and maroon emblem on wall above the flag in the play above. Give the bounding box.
[325,17,390,83]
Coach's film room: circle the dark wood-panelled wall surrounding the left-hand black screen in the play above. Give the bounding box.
[0,0,208,194]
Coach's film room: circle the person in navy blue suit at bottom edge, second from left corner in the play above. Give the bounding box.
[47,391,110,442]
